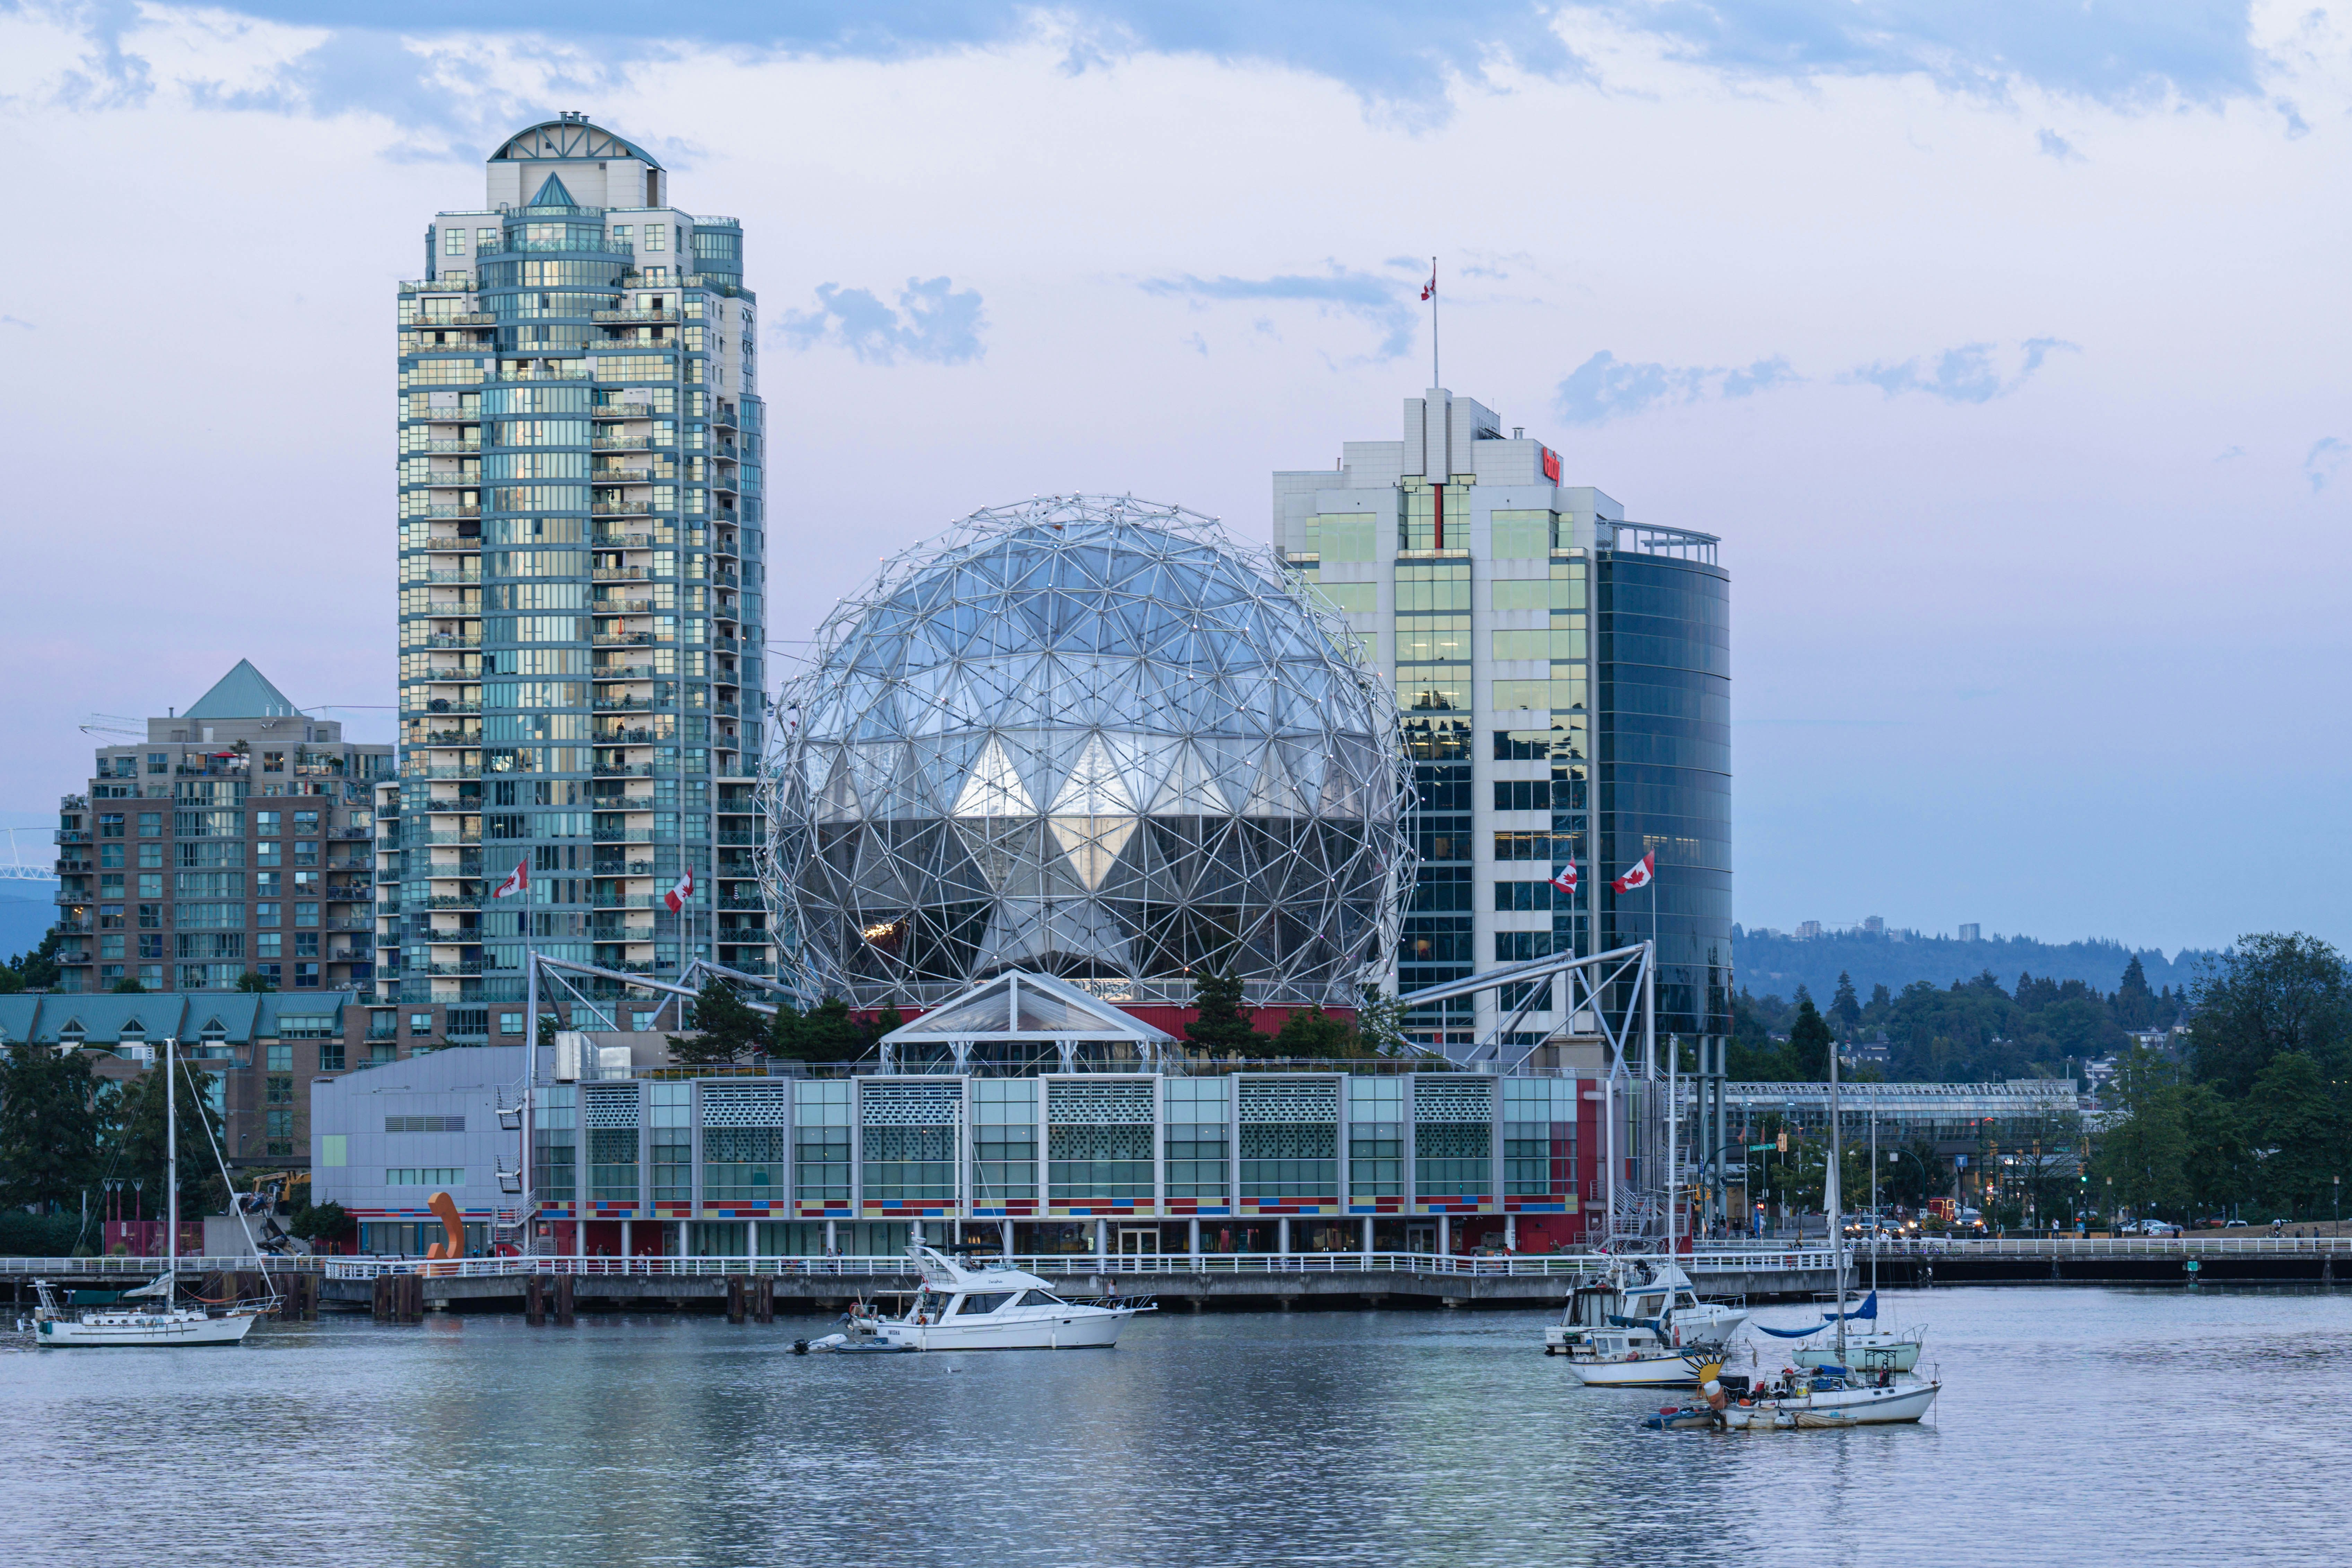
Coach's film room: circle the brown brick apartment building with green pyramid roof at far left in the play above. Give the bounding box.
[56,658,393,992]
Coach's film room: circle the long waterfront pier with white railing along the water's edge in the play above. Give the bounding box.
[0,1237,2352,1321]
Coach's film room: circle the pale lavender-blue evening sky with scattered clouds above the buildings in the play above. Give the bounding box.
[0,0,2352,950]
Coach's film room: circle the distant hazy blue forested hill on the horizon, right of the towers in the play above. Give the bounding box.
[1731,926,2218,1006]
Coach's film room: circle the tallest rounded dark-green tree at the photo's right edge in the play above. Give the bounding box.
[2190,931,2352,1098]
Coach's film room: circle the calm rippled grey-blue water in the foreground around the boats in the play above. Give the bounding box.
[0,1288,2352,1568]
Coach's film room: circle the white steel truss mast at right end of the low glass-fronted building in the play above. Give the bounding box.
[1397,940,1682,1253]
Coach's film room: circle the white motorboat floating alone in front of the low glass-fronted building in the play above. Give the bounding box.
[793,1246,1152,1352]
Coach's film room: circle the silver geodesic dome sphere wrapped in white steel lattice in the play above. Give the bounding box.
[760,496,1411,1006]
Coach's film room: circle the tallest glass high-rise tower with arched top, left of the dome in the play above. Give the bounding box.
[383,115,772,1020]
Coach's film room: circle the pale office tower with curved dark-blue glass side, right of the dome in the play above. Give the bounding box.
[1275,388,1731,1044]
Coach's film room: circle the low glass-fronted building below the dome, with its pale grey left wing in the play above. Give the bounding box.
[311,1046,1602,1258]
